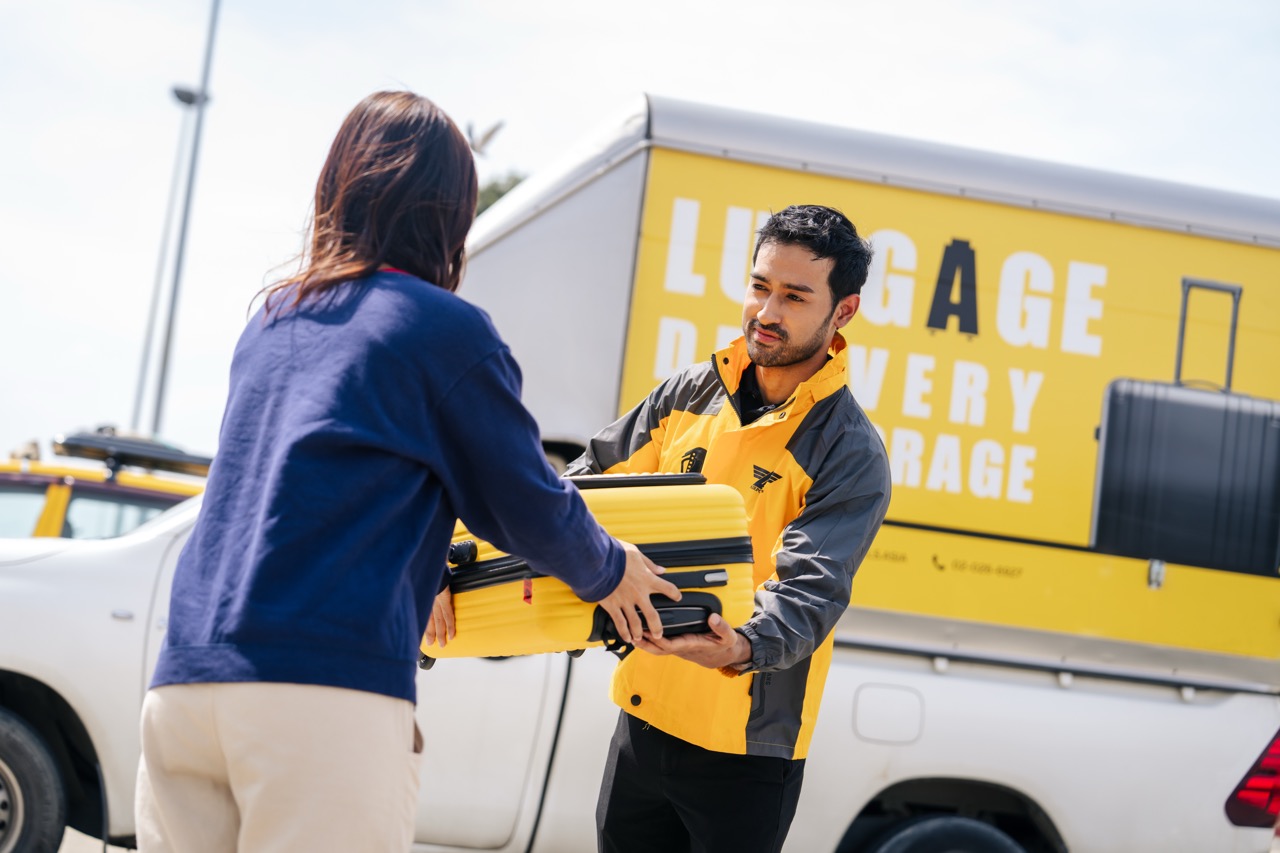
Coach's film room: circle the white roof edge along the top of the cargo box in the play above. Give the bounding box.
[470,95,1280,254]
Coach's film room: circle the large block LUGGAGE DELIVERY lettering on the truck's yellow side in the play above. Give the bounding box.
[654,199,1107,503]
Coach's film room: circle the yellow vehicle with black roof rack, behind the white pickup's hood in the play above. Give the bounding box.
[0,427,212,539]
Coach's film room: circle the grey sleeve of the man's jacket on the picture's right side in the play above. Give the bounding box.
[740,427,890,671]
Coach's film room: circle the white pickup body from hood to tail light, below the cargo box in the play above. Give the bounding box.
[0,498,1280,853]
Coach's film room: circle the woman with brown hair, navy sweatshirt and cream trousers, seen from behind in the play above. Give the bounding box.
[137,92,678,853]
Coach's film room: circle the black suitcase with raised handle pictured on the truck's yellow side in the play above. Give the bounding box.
[1091,279,1280,578]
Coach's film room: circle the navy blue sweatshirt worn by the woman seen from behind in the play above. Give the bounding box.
[151,272,625,701]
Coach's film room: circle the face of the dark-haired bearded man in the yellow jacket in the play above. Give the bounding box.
[742,242,858,368]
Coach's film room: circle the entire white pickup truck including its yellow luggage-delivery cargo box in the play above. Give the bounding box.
[0,97,1280,853]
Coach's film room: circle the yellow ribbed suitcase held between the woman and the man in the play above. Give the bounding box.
[420,474,754,669]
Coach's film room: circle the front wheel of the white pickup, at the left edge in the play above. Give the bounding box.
[0,708,67,853]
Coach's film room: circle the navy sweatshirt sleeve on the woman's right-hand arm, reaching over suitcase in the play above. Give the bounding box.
[436,347,626,601]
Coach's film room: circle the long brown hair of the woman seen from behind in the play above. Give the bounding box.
[266,92,479,311]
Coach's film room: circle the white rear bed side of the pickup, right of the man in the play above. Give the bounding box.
[786,649,1280,853]
